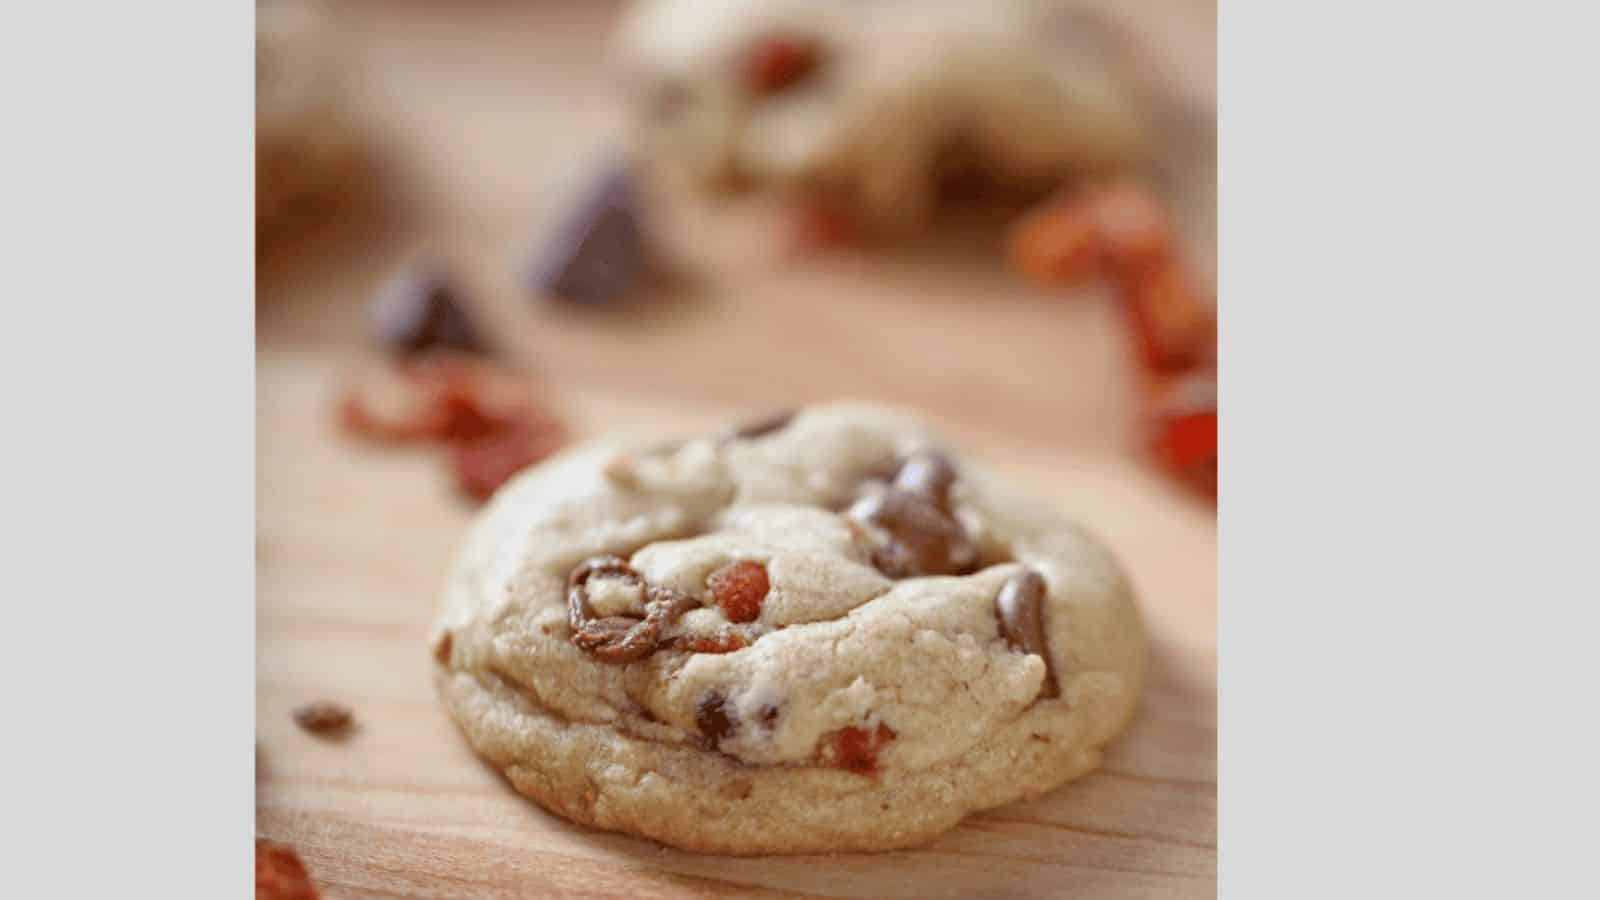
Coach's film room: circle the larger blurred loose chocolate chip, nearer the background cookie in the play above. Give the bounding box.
[531,165,648,306]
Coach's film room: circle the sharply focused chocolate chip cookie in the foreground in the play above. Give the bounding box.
[434,405,1146,854]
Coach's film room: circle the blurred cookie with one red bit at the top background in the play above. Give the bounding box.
[619,0,1149,234]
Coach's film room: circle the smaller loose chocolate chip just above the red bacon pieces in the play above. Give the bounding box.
[368,261,485,356]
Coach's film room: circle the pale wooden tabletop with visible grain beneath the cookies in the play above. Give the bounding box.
[256,2,1216,898]
